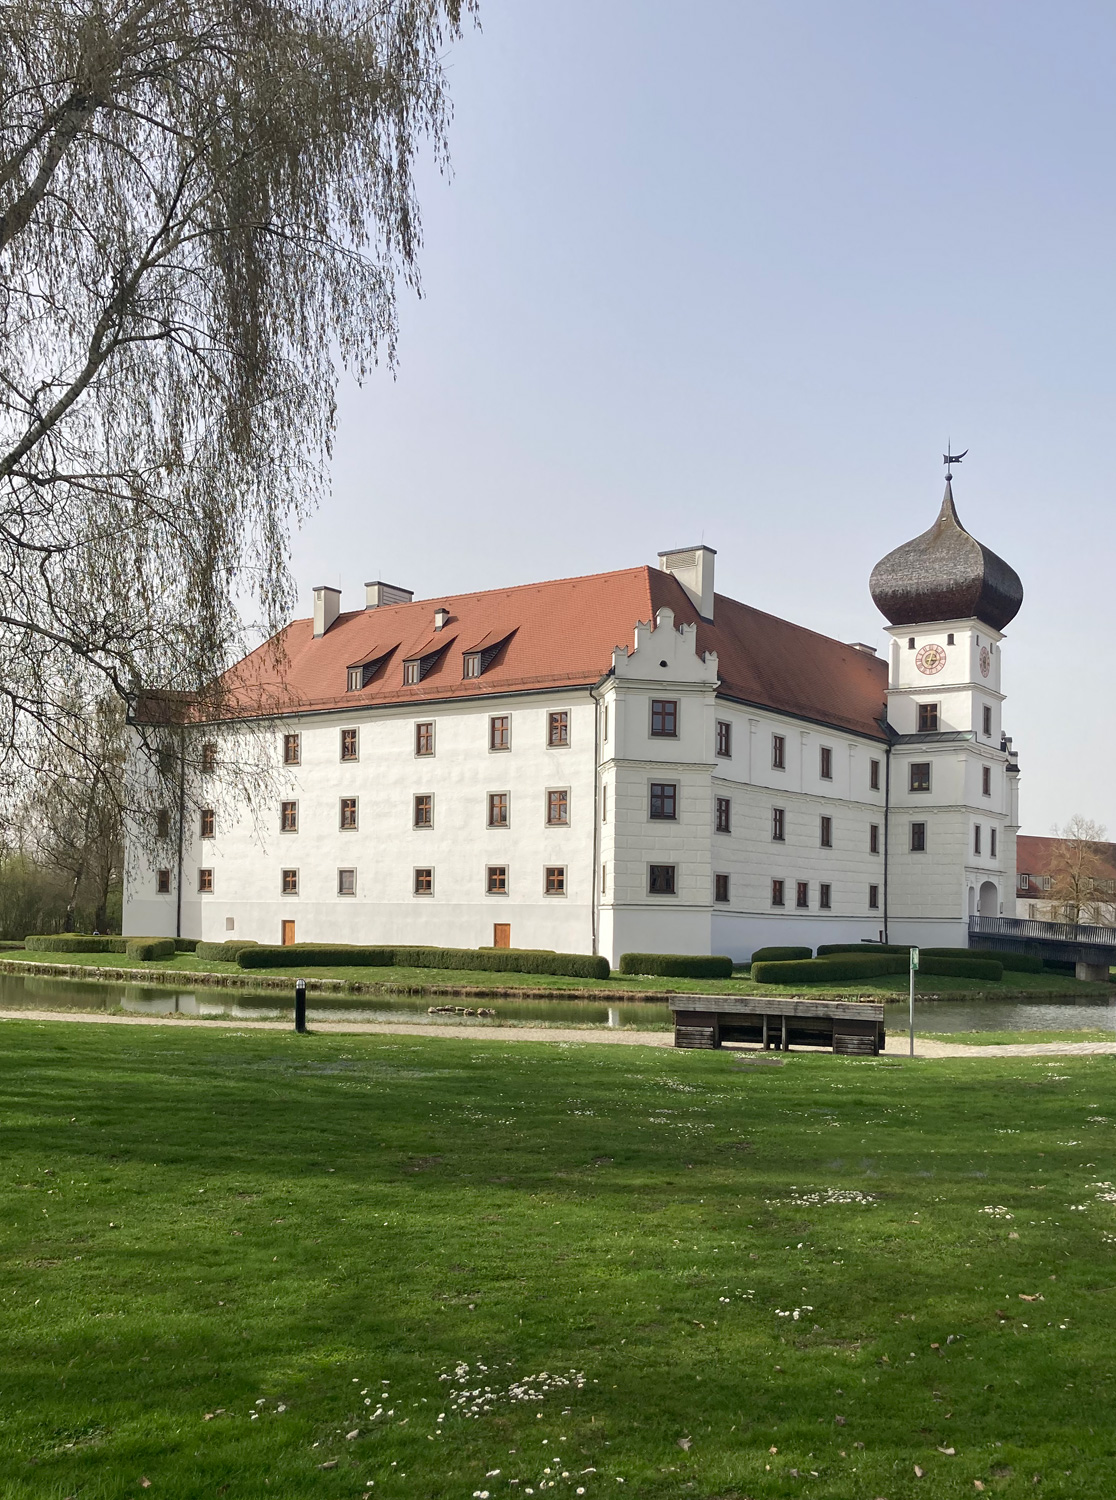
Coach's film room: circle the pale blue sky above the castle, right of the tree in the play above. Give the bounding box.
[294,0,1116,834]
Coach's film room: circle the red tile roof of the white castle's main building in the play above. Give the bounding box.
[213,567,887,741]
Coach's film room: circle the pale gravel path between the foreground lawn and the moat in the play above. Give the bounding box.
[0,1010,1116,1058]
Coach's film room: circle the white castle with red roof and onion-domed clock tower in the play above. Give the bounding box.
[125,480,1023,962]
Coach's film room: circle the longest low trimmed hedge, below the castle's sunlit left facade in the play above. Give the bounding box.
[237,944,609,980]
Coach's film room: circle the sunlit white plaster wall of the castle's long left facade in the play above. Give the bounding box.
[125,692,596,953]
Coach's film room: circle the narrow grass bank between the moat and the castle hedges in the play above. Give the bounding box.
[0,953,1113,1001]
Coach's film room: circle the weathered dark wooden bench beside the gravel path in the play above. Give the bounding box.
[671,995,887,1058]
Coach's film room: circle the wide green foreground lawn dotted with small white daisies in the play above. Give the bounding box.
[0,1022,1116,1500]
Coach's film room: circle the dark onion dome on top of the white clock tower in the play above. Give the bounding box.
[869,477,1023,630]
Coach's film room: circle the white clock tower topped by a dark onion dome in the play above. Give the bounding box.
[870,473,1023,947]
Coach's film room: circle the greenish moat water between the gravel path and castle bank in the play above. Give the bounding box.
[0,974,1116,1041]
